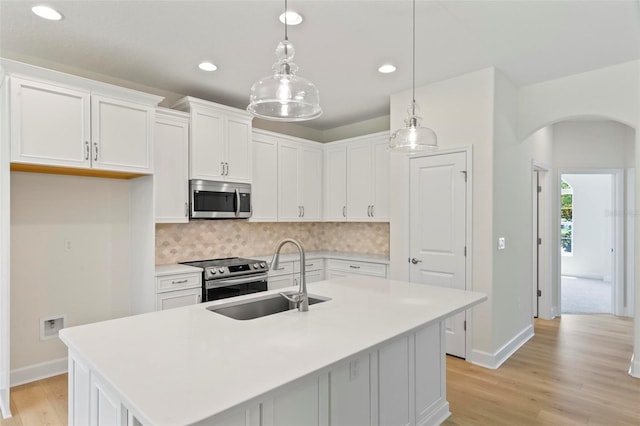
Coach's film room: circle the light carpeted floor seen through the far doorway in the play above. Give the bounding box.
[561,276,612,314]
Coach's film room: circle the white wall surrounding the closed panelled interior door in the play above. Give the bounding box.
[390,68,495,358]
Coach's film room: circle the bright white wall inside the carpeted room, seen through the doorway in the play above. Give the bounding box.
[561,174,613,280]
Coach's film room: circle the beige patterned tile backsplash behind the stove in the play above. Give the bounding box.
[156,220,389,265]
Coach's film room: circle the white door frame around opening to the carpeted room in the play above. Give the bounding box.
[549,168,632,316]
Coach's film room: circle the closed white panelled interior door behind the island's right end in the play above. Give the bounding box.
[409,152,466,358]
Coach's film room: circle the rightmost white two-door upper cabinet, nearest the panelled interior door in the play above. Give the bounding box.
[324,132,389,222]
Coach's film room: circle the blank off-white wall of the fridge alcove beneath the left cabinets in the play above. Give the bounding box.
[11,172,131,380]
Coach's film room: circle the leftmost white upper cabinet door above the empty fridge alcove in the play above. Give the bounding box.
[11,77,91,168]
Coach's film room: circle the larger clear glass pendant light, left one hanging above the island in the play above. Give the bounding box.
[247,0,322,121]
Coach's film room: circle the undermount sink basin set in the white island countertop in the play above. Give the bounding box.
[207,293,330,320]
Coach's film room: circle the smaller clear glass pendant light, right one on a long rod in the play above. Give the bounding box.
[389,0,438,152]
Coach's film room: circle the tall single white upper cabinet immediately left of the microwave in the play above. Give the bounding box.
[153,108,189,223]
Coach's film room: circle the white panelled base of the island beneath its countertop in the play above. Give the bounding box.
[69,321,450,426]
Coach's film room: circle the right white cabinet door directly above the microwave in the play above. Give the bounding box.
[225,117,251,182]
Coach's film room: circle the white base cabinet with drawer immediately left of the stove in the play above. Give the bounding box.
[156,266,202,311]
